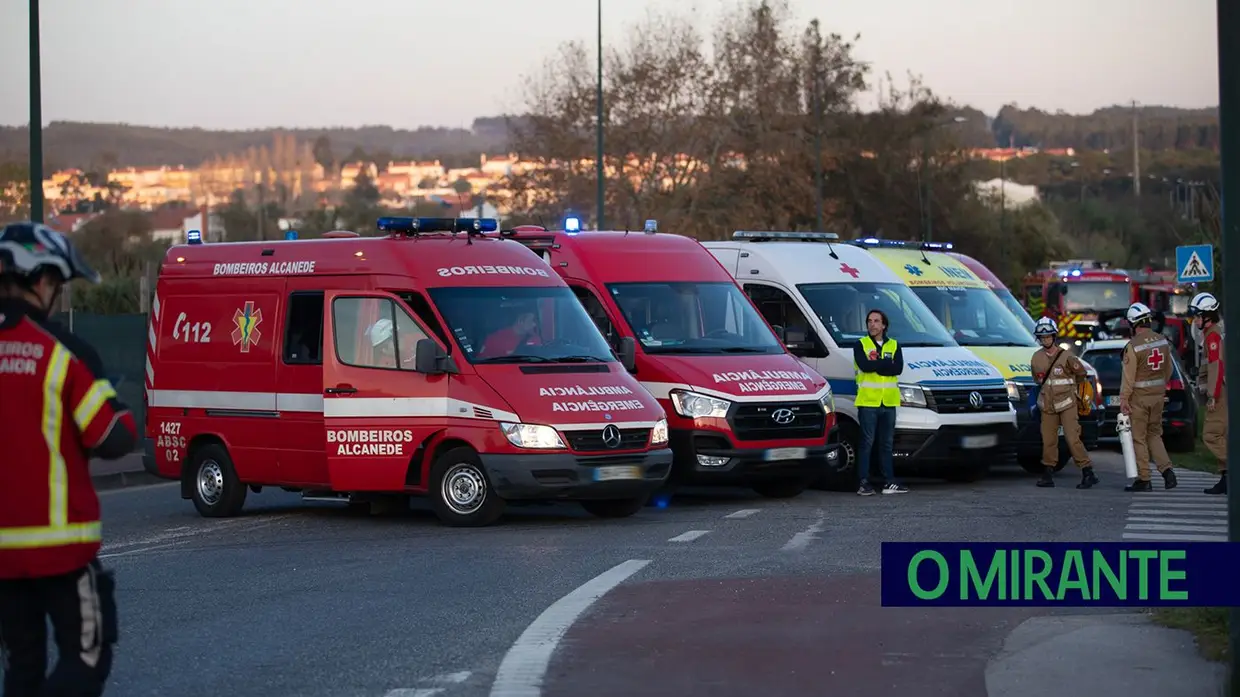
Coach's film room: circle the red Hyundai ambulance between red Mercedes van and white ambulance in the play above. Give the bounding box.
[488,218,838,497]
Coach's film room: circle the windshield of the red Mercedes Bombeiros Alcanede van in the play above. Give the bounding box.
[430,285,616,363]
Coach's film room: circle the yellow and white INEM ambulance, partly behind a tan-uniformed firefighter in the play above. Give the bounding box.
[851,238,1106,474]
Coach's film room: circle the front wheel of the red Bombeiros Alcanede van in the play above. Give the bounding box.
[430,448,505,527]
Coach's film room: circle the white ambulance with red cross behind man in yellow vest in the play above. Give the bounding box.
[703,232,1016,491]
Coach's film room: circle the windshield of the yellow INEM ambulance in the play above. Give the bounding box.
[913,285,1038,347]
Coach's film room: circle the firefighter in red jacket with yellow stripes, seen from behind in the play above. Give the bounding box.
[0,222,136,697]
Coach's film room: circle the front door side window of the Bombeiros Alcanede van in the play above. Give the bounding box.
[331,292,427,370]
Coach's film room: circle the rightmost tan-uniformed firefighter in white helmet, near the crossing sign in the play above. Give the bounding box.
[1188,293,1228,494]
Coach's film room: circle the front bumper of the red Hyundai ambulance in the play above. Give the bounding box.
[670,427,841,486]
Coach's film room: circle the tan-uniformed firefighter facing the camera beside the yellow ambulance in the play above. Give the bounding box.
[1030,317,1099,489]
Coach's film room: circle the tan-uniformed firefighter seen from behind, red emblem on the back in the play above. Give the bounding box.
[1120,303,1176,491]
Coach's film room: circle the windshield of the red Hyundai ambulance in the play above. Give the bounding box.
[608,282,784,353]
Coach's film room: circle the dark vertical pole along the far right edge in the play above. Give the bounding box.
[1218,0,1240,697]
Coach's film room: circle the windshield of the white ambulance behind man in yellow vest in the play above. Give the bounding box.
[797,283,960,349]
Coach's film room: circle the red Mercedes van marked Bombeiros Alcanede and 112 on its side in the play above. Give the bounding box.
[146,218,672,526]
